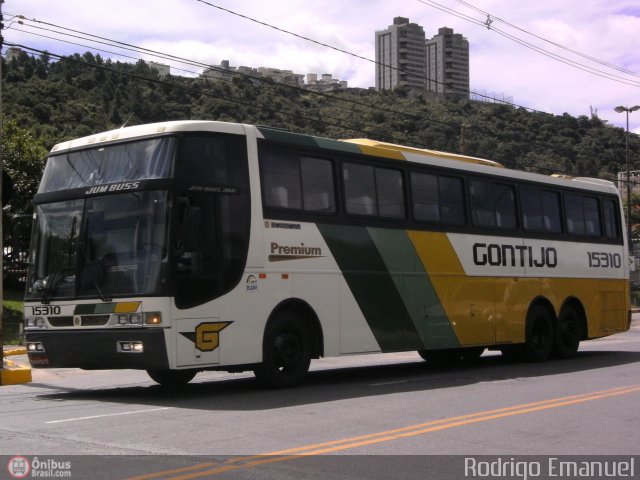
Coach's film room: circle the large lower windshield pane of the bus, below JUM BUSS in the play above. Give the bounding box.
[27,191,169,302]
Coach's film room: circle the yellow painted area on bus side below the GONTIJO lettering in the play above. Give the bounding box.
[409,231,628,346]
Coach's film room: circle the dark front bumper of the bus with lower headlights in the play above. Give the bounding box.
[26,328,169,370]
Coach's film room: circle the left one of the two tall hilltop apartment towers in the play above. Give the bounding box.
[376,17,426,94]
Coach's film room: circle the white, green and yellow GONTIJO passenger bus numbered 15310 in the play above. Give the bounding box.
[25,121,631,387]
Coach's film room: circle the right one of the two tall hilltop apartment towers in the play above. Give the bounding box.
[425,27,469,98]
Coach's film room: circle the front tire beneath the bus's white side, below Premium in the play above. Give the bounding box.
[254,312,311,388]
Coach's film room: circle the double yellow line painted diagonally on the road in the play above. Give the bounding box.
[128,384,640,480]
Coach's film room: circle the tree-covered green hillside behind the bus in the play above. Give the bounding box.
[2,49,640,228]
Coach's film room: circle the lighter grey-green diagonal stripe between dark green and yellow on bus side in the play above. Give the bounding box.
[369,228,460,349]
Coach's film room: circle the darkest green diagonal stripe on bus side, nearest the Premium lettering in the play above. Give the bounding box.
[318,225,424,351]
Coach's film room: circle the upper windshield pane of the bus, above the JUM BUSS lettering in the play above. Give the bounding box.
[38,137,177,193]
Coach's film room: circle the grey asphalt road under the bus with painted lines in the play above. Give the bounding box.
[0,319,640,479]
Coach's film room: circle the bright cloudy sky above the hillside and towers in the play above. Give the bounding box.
[2,0,640,133]
